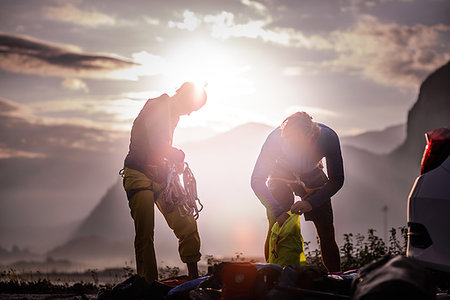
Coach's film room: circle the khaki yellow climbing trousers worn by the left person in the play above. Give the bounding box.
[123,168,201,282]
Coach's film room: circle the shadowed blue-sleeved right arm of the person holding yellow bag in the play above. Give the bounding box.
[306,131,344,209]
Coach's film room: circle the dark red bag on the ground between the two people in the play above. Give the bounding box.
[220,263,257,300]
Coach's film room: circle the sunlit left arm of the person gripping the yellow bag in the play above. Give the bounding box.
[251,132,284,217]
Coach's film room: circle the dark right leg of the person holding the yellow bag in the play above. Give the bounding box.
[305,201,341,272]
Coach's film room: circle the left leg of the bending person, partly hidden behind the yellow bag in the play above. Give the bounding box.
[264,180,294,261]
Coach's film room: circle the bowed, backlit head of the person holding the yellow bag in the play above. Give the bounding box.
[281,112,320,145]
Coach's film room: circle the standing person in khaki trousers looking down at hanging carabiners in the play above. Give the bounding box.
[123,82,206,282]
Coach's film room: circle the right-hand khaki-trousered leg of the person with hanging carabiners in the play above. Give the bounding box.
[156,197,201,278]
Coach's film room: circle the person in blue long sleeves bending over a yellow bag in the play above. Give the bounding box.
[251,112,344,272]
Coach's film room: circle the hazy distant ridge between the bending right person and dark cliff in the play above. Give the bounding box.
[341,124,406,154]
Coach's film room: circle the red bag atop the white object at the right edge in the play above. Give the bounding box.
[420,128,450,174]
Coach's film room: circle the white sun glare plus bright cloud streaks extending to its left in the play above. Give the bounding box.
[115,38,260,131]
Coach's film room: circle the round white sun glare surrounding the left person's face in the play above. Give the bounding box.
[164,39,253,131]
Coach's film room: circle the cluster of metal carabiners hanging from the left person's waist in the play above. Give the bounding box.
[162,162,203,220]
